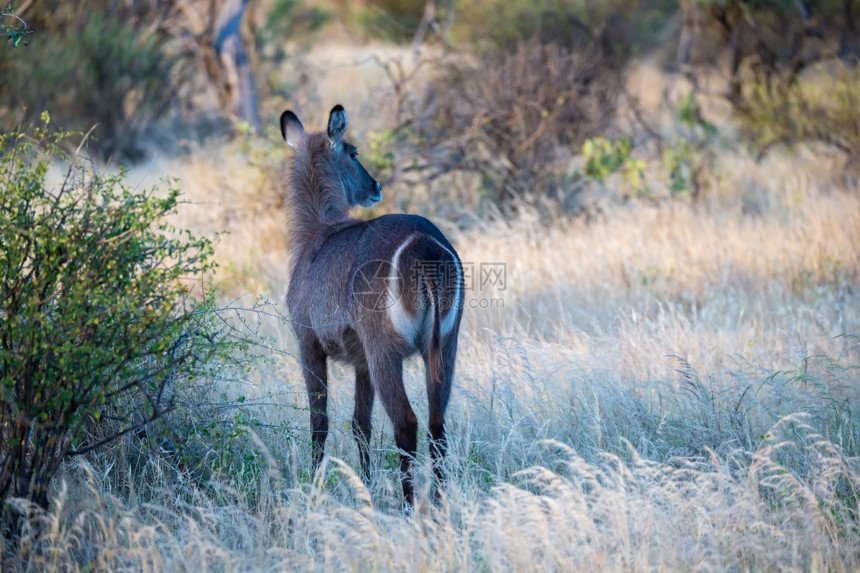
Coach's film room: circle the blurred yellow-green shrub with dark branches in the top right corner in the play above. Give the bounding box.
[678,0,860,170]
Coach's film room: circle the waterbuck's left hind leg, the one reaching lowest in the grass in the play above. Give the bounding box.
[368,353,418,505]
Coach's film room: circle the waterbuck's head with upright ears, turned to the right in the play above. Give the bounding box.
[281,105,382,207]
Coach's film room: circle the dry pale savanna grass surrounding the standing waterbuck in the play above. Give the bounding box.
[2,2,860,572]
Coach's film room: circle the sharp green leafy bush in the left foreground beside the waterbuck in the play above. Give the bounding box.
[0,120,226,533]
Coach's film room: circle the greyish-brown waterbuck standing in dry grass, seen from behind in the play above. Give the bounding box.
[281,105,463,505]
